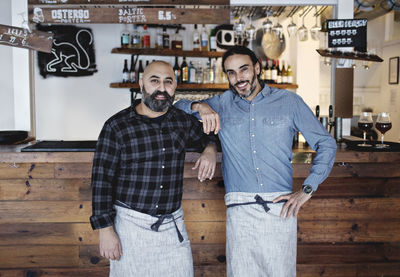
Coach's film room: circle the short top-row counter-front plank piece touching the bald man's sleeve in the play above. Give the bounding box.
[55,163,93,179]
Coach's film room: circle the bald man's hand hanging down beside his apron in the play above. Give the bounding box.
[99,226,122,261]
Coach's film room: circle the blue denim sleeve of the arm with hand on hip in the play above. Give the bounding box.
[294,94,337,190]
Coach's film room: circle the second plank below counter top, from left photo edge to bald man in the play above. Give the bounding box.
[0,179,92,201]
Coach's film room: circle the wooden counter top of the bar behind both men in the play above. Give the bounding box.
[0,143,400,164]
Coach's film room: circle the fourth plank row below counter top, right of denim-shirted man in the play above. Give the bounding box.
[297,218,400,243]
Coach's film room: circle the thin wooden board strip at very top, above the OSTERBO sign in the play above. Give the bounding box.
[28,0,229,5]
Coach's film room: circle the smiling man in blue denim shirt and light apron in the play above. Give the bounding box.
[175,46,337,277]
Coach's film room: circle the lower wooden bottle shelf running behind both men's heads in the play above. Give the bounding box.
[110,83,299,90]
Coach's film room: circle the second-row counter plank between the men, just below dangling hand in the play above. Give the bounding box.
[182,177,225,200]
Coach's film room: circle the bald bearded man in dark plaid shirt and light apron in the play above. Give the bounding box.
[90,61,216,277]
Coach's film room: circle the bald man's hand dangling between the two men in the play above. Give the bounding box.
[192,144,217,182]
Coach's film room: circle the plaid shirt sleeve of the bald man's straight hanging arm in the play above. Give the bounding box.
[90,122,120,229]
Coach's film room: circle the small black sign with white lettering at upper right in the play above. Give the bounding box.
[326,19,368,52]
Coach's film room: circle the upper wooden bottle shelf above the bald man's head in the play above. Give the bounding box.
[111,48,224,58]
